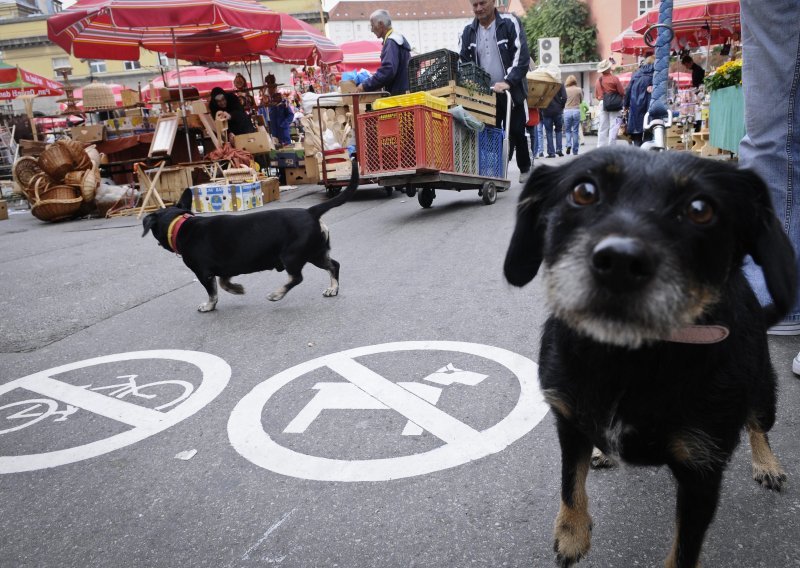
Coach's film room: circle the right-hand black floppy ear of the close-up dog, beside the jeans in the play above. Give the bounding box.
[738,170,797,321]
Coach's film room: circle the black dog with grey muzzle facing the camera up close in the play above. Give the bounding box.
[505,148,797,568]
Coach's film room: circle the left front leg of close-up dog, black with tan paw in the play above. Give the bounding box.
[553,414,592,568]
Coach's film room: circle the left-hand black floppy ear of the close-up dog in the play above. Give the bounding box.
[503,166,558,286]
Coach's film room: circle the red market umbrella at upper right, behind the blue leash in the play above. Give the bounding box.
[631,0,742,48]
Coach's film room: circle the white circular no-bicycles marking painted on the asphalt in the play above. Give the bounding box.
[0,350,231,474]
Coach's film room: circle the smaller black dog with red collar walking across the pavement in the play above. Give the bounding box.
[142,161,358,312]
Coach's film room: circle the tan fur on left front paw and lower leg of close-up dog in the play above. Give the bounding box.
[555,460,592,561]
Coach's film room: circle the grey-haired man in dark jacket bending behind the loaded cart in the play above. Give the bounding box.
[356,10,411,95]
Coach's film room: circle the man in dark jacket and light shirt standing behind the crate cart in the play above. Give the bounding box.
[459,0,531,184]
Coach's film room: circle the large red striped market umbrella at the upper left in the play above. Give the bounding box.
[47,0,280,61]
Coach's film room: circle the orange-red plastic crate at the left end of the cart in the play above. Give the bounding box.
[358,106,453,174]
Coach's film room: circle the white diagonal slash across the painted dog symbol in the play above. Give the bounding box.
[327,358,481,444]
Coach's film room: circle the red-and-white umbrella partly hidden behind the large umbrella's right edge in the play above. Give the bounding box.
[264,14,342,65]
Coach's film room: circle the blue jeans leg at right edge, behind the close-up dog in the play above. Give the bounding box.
[739,0,800,323]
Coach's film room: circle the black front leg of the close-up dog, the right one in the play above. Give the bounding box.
[664,464,722,568]
